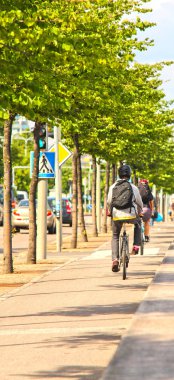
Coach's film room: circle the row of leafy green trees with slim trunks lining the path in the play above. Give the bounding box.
[0,0,174,272]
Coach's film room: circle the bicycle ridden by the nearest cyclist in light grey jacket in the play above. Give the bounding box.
[119,223,130,280]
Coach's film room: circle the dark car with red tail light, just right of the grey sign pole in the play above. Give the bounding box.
[47,197,72,227]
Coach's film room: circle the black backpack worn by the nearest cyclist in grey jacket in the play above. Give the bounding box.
[111,179,134,212]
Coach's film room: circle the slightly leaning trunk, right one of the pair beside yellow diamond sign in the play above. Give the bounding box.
[74,134,88,241]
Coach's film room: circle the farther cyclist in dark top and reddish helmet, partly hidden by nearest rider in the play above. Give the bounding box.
[138,179,154,243]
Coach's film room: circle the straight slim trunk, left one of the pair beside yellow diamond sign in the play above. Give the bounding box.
[71,147,78,248]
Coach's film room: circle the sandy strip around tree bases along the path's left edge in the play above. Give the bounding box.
[0,225,110,295]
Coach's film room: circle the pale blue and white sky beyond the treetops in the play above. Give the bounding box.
[136,0,174,100]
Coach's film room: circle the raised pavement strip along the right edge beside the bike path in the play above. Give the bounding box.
[102,225,174,380]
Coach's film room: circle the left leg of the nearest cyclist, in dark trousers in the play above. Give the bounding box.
[112,220,123,272]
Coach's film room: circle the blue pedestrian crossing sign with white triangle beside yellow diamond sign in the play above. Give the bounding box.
[30,152,55,179]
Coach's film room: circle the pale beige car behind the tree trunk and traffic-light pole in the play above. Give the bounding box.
[12,199,56,234]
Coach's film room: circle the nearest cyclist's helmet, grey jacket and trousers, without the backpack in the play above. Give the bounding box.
[107,164,143,272]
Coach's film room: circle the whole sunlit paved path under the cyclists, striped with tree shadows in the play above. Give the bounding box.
[0,223,174,380]
